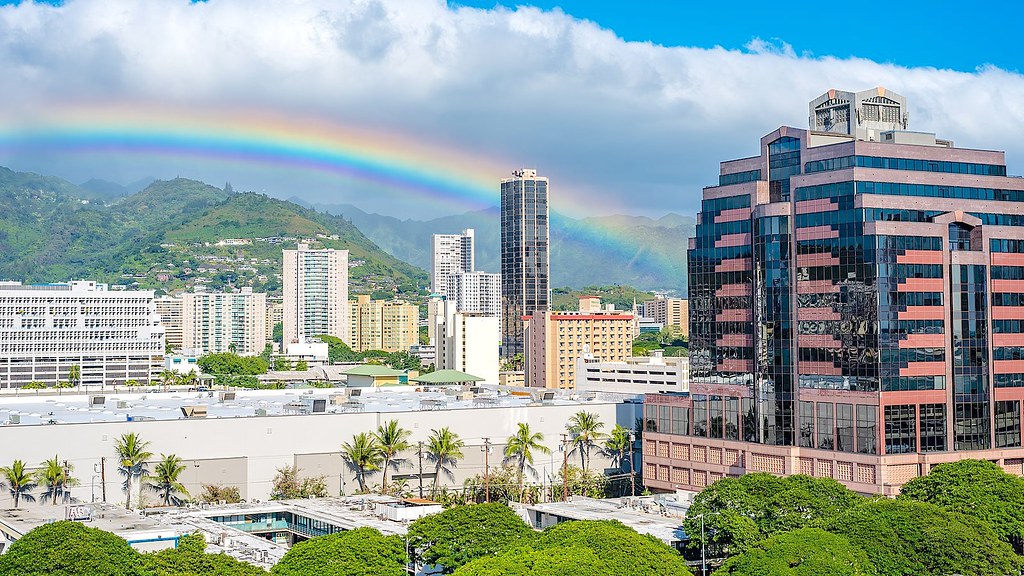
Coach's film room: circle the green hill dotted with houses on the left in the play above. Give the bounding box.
[0,168,427,293]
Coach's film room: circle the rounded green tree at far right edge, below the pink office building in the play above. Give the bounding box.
[899,460,1024,553]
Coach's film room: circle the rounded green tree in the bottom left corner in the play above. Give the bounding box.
[0,521,142,576]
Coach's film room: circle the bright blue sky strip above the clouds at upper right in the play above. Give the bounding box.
[458,0,1024,72]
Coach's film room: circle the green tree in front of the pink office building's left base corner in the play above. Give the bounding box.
[683,472,862,556]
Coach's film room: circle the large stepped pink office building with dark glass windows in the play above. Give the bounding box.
[644,88,1024,494]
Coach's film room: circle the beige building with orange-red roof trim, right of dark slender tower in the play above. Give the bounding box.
[526,297,637,388]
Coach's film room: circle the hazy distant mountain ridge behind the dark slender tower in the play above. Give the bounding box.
[301,199,695,294]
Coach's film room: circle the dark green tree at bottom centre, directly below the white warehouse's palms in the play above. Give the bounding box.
[407,504,534,574]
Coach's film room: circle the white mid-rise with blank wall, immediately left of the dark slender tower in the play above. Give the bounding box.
[427,300,501,384]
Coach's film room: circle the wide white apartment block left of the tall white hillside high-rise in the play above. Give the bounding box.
[181,288,266,356]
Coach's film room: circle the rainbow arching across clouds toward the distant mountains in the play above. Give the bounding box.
[0,102,682,286]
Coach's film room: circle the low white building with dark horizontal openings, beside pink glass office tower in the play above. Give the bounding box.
[575,351,690,394]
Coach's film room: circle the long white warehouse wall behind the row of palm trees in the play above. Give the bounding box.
[0,402,634,508]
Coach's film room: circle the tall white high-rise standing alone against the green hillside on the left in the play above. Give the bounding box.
[282,244,352,352]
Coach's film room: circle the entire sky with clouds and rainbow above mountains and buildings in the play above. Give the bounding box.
[0,0,1024,218]
